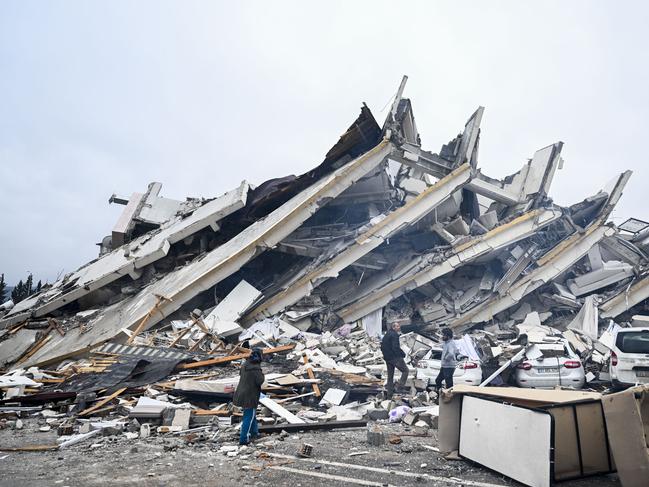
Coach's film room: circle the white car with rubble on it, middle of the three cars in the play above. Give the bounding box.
[514,340,586,389]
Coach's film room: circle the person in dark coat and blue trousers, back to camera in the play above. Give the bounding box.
[232,348,264,445]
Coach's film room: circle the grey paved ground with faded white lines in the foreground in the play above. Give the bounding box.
[0,419,620,487]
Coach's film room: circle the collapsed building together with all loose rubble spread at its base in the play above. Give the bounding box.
[0,77,649,486]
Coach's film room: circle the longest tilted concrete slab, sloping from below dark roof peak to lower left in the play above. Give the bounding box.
[20,140,394,366]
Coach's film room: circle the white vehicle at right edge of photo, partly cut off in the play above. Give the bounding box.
[609,328,649,387]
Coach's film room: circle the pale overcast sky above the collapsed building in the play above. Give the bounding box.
[0,0,649,284]
